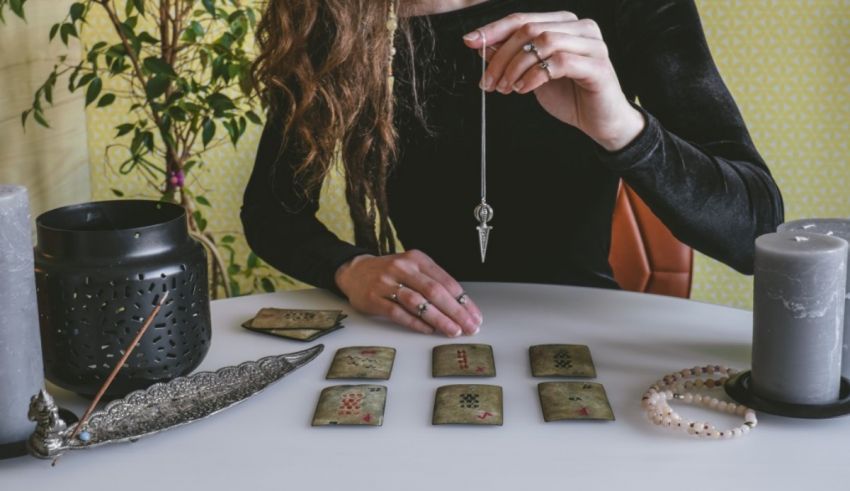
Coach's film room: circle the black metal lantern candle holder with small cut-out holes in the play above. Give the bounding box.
[35,200,211,397]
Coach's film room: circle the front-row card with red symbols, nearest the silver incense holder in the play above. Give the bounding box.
[313,385,387,426]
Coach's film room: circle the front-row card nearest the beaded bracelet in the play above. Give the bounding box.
[537,382,614,423]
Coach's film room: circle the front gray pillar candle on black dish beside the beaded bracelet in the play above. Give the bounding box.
[751,232,848,405]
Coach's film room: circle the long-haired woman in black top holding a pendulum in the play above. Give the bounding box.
[242,0,783,336]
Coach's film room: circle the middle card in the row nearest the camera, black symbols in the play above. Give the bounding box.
[432,385,502,426]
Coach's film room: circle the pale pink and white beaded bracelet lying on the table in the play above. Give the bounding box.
[641,365,758,439]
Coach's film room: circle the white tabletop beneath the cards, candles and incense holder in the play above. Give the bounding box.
[0,283,850,491]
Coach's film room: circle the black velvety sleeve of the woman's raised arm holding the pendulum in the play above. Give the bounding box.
[598,0,784,274]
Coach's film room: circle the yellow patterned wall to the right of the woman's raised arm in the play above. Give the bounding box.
[692,0,850,307]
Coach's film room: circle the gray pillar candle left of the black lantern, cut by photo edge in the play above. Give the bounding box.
[0,185,44,452]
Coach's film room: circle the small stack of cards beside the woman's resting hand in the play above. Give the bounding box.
[242,308,347,342]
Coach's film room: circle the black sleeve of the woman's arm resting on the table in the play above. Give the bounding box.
[241,108,370,294]
